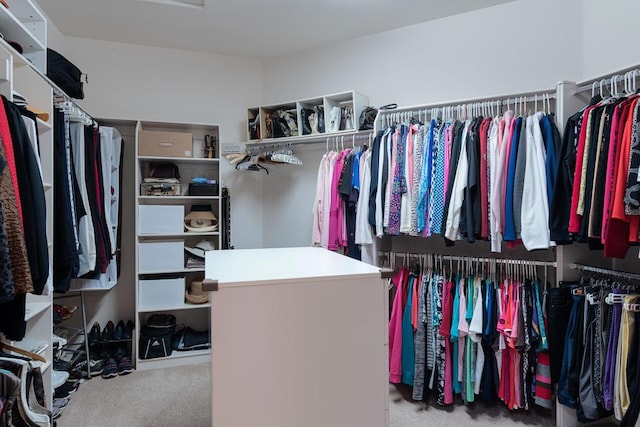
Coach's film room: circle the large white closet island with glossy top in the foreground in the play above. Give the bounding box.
[205,247,389,427]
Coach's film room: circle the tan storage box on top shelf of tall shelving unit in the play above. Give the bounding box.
[138,130,193,157]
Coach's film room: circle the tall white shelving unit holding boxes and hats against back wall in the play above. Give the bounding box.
[134,121,222,370]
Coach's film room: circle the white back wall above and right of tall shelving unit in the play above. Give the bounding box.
[64,37,262,248]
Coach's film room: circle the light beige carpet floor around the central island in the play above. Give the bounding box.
[57,364,554,427]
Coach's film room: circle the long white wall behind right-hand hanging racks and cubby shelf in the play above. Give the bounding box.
[264,0,582,247]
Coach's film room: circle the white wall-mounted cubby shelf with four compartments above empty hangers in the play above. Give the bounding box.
[247,91,369,142]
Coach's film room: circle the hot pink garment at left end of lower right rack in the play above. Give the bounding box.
[389,269,409,384]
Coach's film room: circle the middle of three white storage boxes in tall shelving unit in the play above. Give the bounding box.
[138,240,184,273]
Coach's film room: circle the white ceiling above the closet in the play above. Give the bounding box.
[37,0,513,58]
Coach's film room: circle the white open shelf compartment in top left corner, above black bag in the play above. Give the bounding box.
[0,0,47,74]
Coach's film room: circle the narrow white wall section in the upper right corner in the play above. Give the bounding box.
[580,0,640,80]
